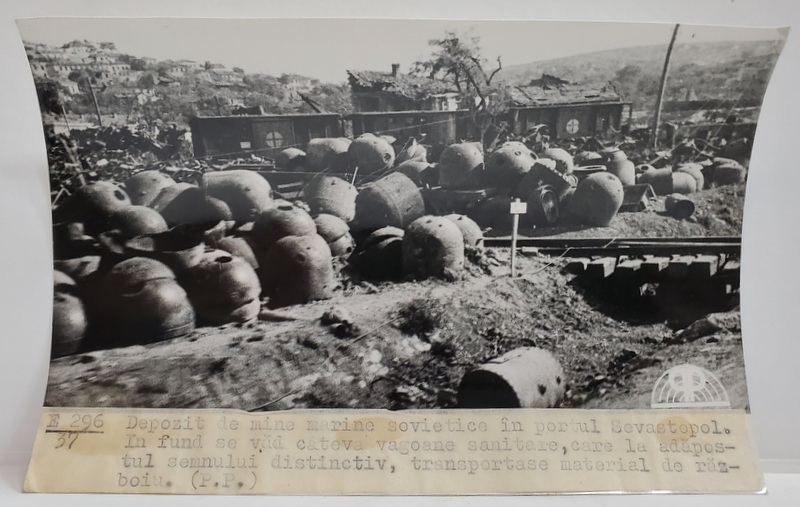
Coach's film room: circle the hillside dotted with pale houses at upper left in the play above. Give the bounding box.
[25,40,351,126]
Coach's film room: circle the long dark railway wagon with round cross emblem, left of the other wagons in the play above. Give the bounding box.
[194,113,344,158]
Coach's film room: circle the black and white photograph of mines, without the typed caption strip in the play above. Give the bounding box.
[18,18,787,412]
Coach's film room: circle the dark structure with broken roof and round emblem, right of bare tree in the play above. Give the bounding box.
[509,74,630,139]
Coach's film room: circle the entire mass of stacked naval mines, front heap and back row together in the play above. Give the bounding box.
[53,134,745,355]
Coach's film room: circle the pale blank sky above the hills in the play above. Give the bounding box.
[17,18,786,82]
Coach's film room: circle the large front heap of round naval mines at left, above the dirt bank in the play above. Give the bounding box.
[53,138,482,356]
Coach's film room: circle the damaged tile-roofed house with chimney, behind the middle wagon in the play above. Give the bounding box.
[347,64,458,112]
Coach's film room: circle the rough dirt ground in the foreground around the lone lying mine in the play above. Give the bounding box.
[45,185,748,410]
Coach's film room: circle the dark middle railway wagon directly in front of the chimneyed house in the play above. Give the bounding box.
[346,110,469,146]
